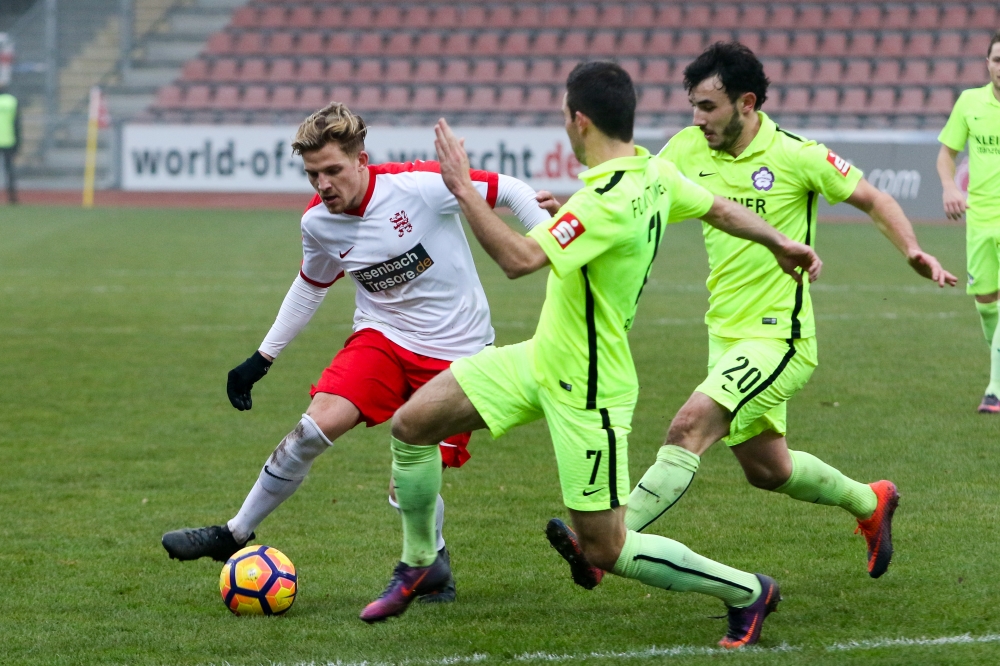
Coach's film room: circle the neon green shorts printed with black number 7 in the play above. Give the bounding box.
[451,340,635,511]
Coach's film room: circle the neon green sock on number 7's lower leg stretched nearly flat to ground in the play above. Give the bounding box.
[612,530,760,608]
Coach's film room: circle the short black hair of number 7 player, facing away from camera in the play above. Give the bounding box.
[566,62,636,141]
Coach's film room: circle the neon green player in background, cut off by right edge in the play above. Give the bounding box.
[937,32,1000,414]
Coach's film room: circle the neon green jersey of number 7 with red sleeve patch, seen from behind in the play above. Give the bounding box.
[528,147,714,409]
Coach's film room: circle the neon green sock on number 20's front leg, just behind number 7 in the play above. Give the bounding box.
[625,444,701,532]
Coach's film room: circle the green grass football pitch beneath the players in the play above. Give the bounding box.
[0,207,1000,666]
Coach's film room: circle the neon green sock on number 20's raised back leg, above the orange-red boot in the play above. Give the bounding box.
[774,451,878,519]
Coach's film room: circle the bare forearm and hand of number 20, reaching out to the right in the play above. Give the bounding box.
[847,180,958,287]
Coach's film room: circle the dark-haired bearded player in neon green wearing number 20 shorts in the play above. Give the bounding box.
[552,42,956,584]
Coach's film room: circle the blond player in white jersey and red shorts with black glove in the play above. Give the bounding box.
[163,103,550,601]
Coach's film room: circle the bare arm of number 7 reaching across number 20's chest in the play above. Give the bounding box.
[701,196,823,282]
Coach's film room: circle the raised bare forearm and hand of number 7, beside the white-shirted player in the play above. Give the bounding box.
[434,119,549,279]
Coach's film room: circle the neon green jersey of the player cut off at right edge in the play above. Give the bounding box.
[938,83,1000,226]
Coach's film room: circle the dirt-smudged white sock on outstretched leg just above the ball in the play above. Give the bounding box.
[227,414,333,543]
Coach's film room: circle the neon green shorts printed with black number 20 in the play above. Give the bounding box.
[695,335,818,446]
